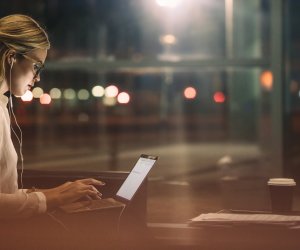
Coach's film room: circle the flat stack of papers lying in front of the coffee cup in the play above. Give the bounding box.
[190,213,300,227]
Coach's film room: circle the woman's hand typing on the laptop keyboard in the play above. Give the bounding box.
[42,178,105,209]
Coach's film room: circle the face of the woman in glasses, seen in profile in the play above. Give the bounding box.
[7,49,47,96]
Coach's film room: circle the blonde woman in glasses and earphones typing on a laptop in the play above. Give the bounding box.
[0,15,104,218]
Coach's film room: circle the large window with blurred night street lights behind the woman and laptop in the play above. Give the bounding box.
[1,0,286,222]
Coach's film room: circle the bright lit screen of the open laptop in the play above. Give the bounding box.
[117,154,157,200]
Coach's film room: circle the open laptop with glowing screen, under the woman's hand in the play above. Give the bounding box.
[60,154,158,213]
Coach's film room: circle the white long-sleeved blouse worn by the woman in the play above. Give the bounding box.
[0,94,47,219]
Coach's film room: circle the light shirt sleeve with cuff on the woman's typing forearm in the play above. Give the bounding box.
[0,189,47,219]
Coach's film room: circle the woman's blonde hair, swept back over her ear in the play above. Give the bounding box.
[0,14,50,86]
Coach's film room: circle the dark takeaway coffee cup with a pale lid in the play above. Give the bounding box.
[268,178,296,213]
